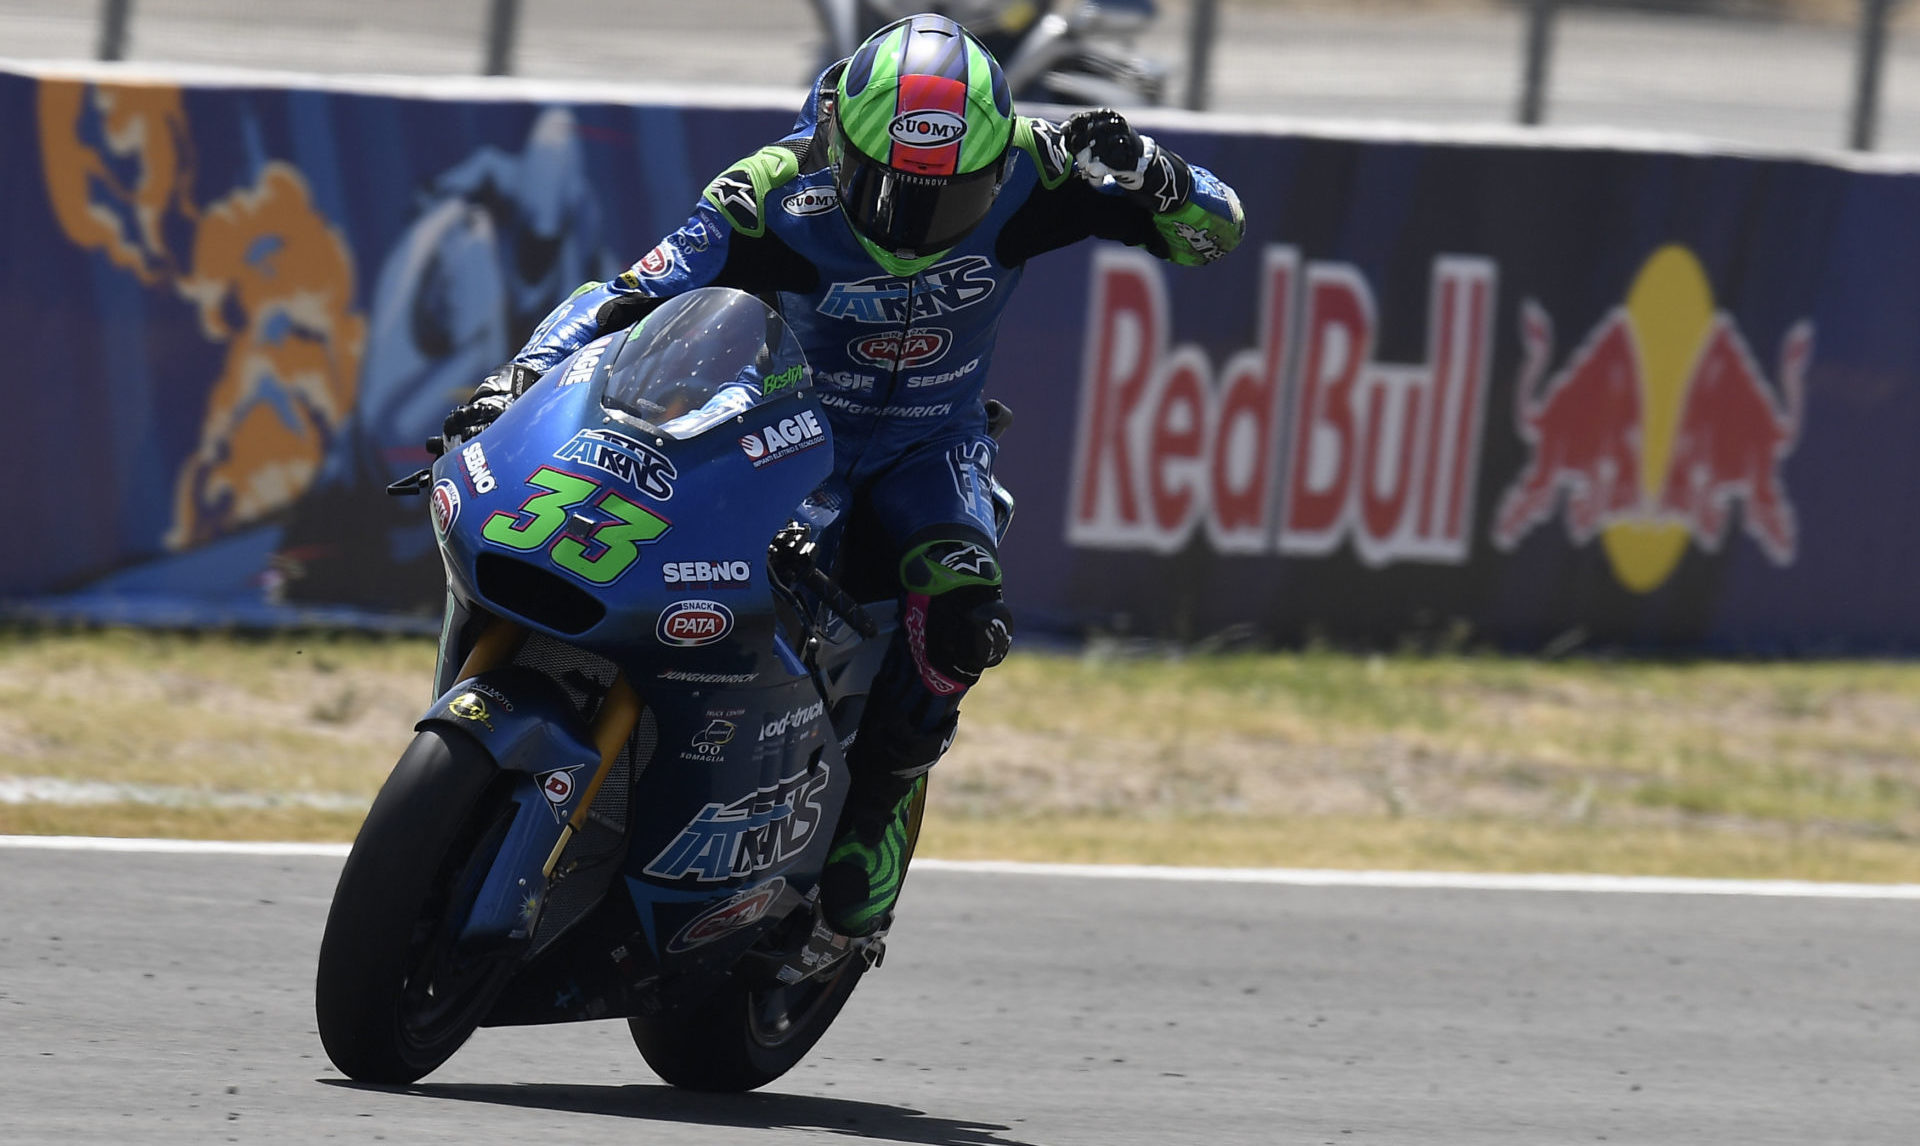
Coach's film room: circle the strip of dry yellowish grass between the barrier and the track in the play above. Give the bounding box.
[0,632,1920,879]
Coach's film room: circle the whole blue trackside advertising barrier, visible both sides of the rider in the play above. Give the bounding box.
[11,73,1920,653]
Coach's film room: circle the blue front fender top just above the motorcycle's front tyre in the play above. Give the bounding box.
[413,666,599,774]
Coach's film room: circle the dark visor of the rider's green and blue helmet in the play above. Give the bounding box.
[833,117,1006,259]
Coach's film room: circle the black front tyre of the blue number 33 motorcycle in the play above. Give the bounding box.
[313,728,516,1085]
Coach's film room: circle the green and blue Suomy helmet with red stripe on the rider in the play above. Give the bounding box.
[828,15,1014,276]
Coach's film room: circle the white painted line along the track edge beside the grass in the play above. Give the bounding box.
[0,835,1920,900]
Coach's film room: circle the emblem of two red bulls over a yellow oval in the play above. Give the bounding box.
[1494,246,1814,593]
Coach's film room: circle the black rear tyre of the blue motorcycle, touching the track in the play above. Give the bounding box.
[626,954,866,1090]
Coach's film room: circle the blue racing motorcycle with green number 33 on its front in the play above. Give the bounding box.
[315,288,1012,1090]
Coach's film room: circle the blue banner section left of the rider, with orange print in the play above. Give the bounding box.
[0,73,793,624]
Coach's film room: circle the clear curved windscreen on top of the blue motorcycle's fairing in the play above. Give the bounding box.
[601,286,812,442]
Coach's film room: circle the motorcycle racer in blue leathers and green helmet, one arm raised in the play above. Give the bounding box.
[445,15,1246,935]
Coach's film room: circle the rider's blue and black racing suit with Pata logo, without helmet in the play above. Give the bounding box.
[515,65,1244,776]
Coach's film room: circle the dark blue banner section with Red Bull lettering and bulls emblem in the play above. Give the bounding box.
[1000,132,1920,653]
